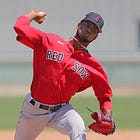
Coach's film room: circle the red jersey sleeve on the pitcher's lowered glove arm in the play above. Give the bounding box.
[89,59,113,111]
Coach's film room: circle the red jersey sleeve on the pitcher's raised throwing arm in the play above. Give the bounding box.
[14,16,47,49]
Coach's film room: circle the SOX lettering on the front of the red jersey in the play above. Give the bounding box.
[72,62,90,79]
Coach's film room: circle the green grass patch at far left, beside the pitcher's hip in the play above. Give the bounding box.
[0,97,23,129]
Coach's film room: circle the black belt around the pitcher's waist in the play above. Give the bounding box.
[30,99,67,112]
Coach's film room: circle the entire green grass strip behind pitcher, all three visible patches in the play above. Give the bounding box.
[0,97,140,129]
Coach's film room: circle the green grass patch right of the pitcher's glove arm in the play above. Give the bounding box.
[113,96,140,129]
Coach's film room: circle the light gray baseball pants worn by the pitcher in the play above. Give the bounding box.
[14,94,86,140]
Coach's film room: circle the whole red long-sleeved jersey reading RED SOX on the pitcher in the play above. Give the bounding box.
[14,16,112,110]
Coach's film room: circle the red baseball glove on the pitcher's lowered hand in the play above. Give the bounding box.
[88,112,116,136]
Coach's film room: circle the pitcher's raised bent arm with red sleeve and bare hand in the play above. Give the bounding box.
[14,10,46,48]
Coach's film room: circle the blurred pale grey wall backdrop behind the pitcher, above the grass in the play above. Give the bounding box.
[0,0,140,95]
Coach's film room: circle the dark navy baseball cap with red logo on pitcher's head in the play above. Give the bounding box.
[81,12,104,33]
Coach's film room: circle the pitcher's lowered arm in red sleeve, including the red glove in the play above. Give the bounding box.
[89,70,116,135]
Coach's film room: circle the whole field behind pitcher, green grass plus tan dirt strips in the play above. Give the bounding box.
[0,87,140,140]
